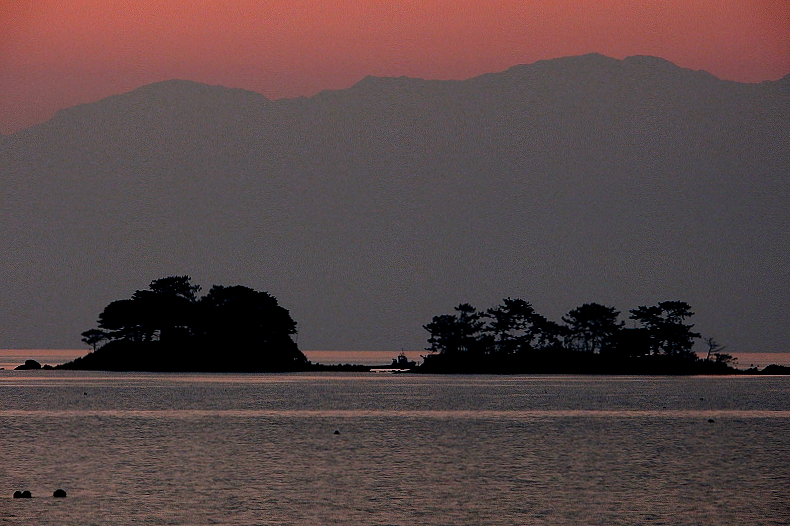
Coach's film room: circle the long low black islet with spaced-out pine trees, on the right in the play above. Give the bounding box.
[415,298,790,375]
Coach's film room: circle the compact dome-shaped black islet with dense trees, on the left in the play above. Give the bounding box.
[57,276,311,372]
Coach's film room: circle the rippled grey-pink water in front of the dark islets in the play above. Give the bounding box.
[0,371,790,525]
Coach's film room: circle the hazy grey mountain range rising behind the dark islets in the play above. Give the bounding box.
[0,55,790,351]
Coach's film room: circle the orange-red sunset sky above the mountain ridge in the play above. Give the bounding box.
[0,0,790,134]
